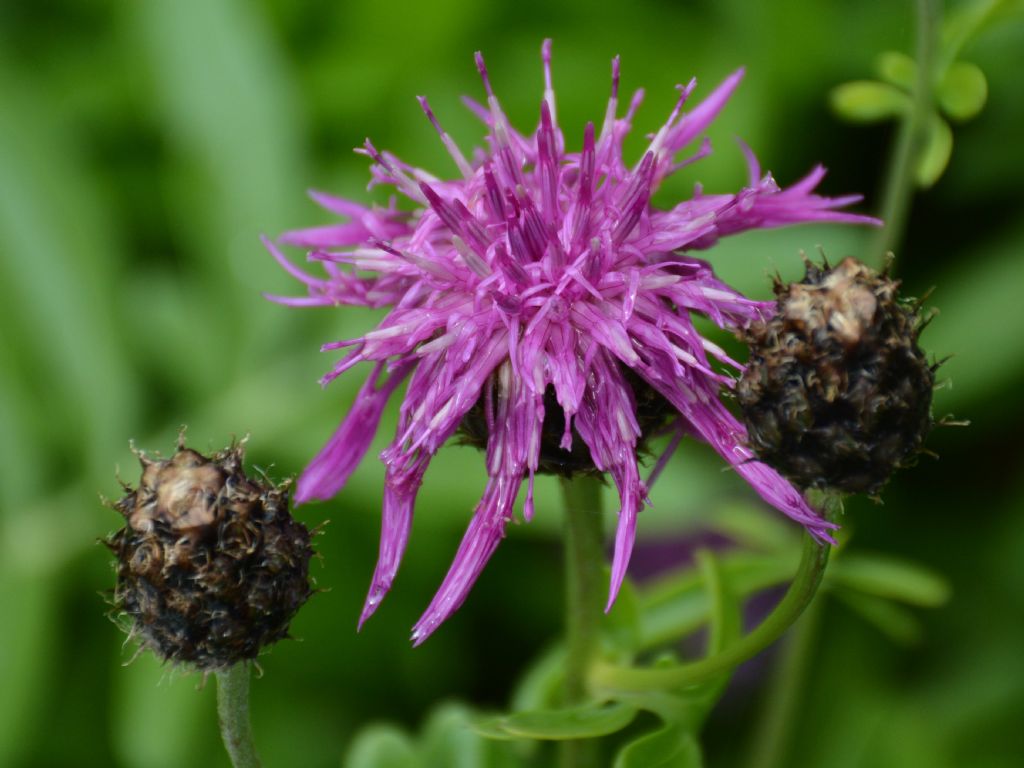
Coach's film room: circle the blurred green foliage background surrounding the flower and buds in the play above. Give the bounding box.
[0,0,1024,768]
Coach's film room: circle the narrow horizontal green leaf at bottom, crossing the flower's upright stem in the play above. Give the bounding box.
[474,703,637,741]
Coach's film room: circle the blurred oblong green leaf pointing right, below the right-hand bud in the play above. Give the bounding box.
[825,553,950,608]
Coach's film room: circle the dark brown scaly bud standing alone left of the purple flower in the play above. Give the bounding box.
[106,442,312,670]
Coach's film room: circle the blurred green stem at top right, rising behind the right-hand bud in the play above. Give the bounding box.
[869,0,942,264]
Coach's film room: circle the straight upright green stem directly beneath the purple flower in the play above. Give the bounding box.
[560,475,607,768]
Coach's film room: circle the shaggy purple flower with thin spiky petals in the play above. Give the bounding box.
[265,41,874,643]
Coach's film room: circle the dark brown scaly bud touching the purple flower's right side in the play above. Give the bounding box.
[736,258,935,494]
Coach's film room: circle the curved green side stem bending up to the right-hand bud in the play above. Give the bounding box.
[590,535,830,693]
